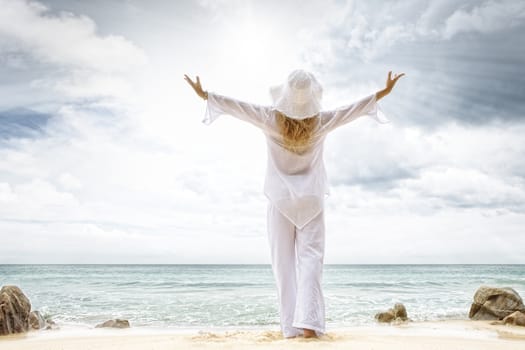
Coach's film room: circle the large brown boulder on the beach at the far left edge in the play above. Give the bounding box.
[0,286,31,335]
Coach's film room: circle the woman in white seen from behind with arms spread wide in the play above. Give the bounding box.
[185,70,404,338]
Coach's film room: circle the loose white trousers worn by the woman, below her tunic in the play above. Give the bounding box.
[268,204,325,338]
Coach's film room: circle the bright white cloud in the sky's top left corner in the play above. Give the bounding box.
[0,0,145,72]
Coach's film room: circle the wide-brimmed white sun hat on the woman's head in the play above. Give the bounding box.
[270,69,323,120]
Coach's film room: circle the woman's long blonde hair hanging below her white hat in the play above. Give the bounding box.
[276,111,317,154]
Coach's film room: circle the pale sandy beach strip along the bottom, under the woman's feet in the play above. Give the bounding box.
[0,321,525,350]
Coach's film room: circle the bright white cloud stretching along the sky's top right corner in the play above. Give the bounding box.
[316,0,525,63]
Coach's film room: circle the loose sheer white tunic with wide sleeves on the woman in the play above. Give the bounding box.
[203,92,389,228]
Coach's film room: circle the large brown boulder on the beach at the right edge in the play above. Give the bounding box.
[469,286,525,320]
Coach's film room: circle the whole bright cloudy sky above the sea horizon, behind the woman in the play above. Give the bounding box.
[0,0,525,264]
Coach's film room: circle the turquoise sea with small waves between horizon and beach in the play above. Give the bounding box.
[0,265,525,328]
